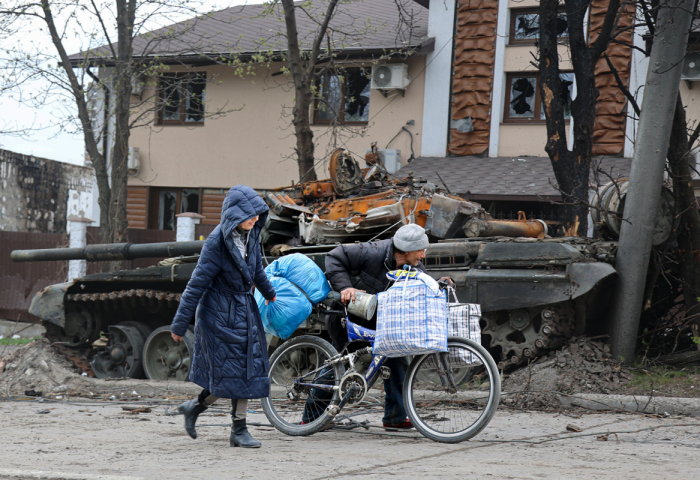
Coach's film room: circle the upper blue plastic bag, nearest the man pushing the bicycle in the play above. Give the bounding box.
[265,253,331,303]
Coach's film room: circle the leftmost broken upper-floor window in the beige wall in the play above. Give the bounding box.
[158,73,207,125]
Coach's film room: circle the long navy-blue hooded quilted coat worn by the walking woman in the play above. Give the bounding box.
[171,185,275,398]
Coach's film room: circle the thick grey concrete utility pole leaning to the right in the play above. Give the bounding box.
[611,0,695,363]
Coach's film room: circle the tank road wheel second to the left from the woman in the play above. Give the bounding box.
[92,322,151,378]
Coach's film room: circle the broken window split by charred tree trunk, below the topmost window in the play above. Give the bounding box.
[503,73,574,123]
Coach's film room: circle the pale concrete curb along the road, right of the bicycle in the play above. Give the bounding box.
[557,393,700,417]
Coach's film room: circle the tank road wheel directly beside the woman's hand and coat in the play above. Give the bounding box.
[143,325,194,382]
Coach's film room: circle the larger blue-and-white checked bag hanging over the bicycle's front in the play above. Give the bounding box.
[373,270,447,357]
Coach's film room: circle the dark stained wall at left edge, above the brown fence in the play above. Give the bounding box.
[0,150,96,233]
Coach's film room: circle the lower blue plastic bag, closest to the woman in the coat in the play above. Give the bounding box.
[255,276,313,340]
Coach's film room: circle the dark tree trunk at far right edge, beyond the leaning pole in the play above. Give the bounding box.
[668,93,700,337]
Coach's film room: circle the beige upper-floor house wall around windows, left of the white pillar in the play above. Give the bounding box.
[129,57,425,189]
